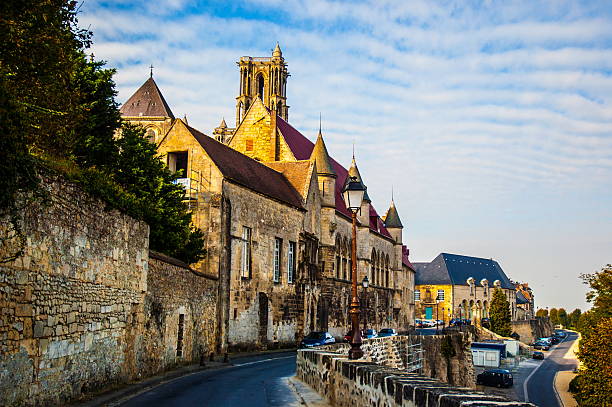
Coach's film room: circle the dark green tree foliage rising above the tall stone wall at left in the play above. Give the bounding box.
[0,0,203,263]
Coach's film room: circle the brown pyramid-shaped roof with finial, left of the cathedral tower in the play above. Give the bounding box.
[119,77,174,119]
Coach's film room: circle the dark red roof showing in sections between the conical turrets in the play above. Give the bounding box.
[276,117,391,238]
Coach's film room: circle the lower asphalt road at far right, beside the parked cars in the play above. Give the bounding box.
[525,332,578,407]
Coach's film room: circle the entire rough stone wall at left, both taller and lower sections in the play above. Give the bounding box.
[0,177,218,405]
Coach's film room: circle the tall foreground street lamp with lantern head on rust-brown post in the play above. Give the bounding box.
[342,177,365,359]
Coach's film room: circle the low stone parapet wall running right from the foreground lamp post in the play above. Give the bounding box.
[297,338,534,407]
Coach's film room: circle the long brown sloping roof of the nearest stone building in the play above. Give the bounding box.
[185,124,304,209]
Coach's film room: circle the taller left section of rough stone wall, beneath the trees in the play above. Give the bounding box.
[0,178,149,405]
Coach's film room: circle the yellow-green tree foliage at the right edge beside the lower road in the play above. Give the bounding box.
[571,264,612,407]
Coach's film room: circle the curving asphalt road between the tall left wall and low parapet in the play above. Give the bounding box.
[119,352,300,407]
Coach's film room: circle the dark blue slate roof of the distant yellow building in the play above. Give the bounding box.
[413,253,514,290]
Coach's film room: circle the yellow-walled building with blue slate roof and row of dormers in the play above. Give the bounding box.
[414,253,517,324]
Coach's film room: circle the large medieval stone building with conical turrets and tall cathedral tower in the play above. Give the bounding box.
[121,45,414,348]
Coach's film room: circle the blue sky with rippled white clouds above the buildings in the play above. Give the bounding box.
[79,0,612,311]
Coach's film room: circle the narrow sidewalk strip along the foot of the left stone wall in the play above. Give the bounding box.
[70,349,296,407]
